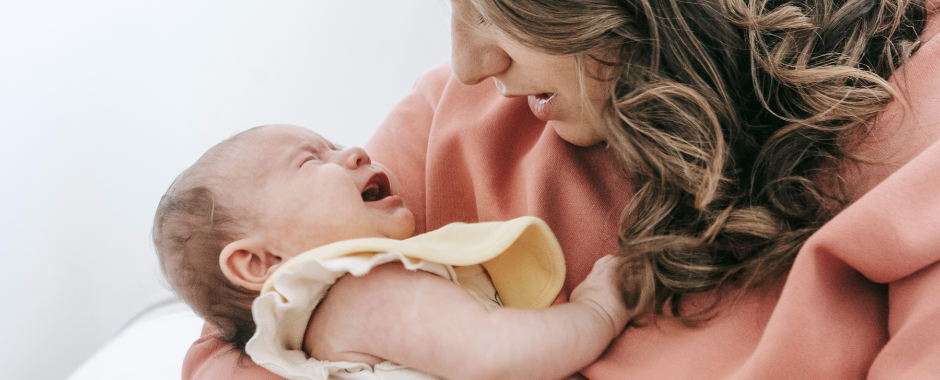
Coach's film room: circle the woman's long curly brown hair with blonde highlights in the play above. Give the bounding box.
[471,0,926,324]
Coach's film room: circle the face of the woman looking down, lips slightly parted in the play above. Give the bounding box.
[451,0,613,146]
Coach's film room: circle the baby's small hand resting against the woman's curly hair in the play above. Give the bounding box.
[569,255,629,336]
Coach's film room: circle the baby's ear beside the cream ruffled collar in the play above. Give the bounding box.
[219,238,281,292]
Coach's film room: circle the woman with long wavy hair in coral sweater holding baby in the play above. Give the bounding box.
[184,0,940,379]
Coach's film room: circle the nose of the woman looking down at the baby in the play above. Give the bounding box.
[451,15,512,85]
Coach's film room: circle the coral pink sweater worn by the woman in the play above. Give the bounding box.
[183,6,940,380]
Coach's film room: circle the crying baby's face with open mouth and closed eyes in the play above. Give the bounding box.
[232,125,414,259]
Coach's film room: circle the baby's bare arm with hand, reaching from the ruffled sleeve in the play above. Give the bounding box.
[304,257,627,379]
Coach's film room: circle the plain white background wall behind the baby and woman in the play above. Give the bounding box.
[0,0,450,379]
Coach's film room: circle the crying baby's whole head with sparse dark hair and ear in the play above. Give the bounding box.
[153,125,414,348]
